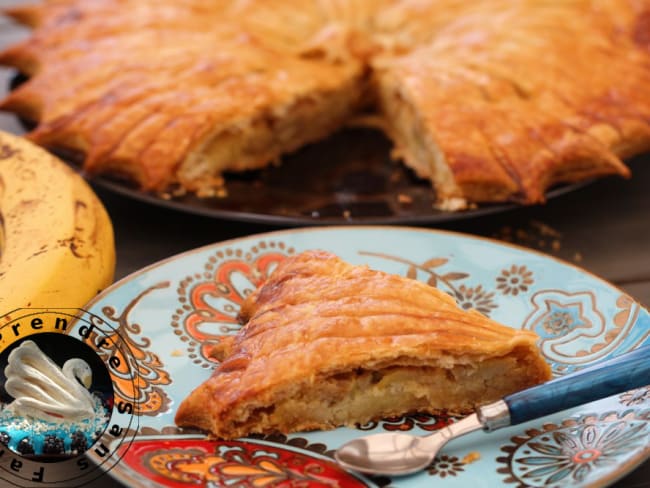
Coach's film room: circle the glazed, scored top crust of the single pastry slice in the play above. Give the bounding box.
[216,251,538,382]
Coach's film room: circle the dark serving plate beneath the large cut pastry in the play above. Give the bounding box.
[10,74,589,226]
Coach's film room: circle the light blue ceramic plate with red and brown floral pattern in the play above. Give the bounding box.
[83,227,650,488]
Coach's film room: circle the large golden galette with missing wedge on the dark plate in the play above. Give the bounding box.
[0,0,650,209]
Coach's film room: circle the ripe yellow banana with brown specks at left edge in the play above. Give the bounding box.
[0,131,115,317]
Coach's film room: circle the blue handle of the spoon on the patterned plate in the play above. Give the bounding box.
[503,346,650,425]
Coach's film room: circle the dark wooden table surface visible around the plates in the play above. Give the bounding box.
[0,4,650,488]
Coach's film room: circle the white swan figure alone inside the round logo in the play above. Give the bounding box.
[5,340,95,421]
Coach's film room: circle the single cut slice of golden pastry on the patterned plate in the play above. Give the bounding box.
[176,251,550,439]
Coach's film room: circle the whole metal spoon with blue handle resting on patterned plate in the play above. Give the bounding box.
[334,346,650,475]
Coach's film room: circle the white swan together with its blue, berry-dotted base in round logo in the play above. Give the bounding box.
[0,337,111,459]
